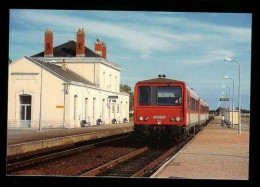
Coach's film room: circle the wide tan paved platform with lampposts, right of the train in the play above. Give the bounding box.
[151,117,249,180]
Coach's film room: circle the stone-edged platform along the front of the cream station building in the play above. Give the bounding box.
[7,121,134,156]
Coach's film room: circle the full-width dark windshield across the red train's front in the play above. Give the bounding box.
[138,86,182,105]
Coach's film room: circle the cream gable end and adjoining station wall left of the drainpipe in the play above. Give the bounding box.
[8,58,64,128]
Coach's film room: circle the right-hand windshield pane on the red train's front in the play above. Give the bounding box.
[157,86,181,105]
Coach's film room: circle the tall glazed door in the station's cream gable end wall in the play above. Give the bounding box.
[19,95,32,127]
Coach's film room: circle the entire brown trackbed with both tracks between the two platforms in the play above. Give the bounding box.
[7,118,213,177]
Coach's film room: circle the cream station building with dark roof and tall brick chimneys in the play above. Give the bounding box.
[8,28,129,128]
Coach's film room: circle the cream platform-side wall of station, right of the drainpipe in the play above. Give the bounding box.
[66,85,129,128]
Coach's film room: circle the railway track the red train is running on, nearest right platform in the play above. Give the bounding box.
[81,137,192,177]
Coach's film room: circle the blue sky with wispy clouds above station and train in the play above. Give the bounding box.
[9,9,252,110]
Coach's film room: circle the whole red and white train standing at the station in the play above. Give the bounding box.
[134,78,209,139]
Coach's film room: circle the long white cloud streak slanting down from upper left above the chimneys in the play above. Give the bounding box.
[14,11,175,56]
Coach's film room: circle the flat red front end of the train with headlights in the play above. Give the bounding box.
[134,78,186,140]
